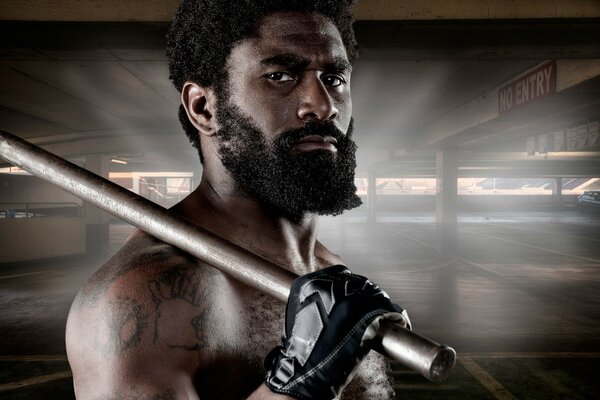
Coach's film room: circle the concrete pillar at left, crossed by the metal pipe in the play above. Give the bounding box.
[83,154,110,254]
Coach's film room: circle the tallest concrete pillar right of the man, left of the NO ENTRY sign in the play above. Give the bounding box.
[435,149,458,254]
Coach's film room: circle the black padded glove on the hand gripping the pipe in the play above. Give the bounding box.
[265,265,410,400]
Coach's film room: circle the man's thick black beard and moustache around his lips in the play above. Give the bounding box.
[217,101,362,220]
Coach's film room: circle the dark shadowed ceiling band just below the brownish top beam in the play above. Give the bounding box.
[0,20,600,62]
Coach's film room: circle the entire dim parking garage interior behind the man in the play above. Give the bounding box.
[0,0,600,399]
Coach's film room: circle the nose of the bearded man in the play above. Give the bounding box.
[298,77,339,121]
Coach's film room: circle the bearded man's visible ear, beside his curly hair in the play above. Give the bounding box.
[181,81,217,136]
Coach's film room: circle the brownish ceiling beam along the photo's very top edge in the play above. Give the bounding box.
[0,0,600,22]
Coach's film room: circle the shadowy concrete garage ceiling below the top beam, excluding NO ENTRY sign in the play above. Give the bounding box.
[0,19,600,175]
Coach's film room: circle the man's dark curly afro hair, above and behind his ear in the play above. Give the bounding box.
[167,0,358,161]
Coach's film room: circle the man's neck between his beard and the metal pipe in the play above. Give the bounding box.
[174,177,328,274]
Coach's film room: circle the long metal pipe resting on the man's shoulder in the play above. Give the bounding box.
[0,130,456,382]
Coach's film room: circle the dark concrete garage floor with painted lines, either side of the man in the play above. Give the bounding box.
[0,211,600,399]
